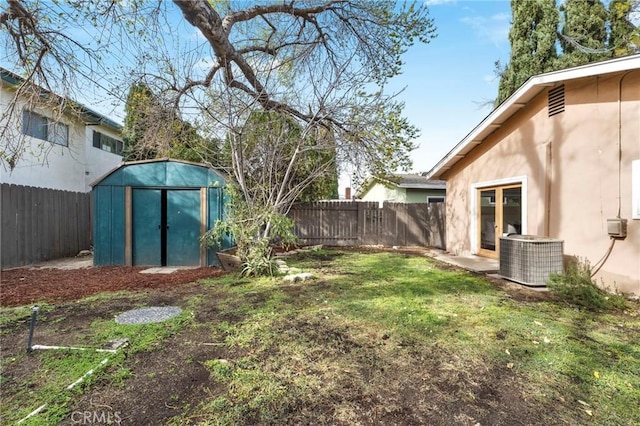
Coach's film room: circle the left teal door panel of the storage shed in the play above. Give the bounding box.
[132,188,162,266]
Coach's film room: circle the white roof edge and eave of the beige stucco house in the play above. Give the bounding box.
[426,54,640,179]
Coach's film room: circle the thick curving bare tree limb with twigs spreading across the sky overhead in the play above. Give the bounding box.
[0,0,434,171]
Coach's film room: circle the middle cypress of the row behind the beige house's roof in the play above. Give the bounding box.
[558,0,612,68]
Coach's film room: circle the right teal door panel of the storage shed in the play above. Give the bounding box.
[166,189,200,266]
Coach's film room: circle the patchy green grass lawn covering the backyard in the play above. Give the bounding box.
[0,250,640,425]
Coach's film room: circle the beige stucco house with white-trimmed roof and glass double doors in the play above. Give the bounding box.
[427,55,640,294]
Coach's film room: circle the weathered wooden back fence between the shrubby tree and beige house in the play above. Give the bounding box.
[289,201,445,249]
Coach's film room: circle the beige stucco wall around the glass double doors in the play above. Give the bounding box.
[443,70,640,294]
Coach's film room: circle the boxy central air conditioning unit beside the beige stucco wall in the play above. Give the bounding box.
[500,235,564,286]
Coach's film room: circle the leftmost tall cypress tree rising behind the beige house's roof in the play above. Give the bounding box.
[495,0,559,106]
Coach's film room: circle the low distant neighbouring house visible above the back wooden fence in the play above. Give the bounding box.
[355,174,446,203]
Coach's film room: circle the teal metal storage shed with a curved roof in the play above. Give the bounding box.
[92,159,232,266]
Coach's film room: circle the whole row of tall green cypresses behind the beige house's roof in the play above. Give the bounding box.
[494,0,640,107]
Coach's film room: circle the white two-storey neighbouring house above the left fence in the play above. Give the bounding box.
[0,68,122,193]
